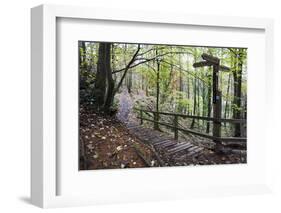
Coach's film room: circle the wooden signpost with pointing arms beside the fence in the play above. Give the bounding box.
[193,53,230,152]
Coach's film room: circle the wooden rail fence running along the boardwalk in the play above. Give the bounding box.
[135,108,247,142]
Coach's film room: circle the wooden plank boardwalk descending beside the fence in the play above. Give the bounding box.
[126,123,206,166]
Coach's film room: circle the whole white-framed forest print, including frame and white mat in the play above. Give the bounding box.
[31,5,273,207]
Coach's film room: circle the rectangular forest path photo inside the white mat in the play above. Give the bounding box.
[77,41,247,170]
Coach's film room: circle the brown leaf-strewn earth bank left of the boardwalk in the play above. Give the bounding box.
[80,107,162,169]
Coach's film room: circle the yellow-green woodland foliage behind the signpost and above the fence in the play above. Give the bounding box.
[79,42,247,121]
